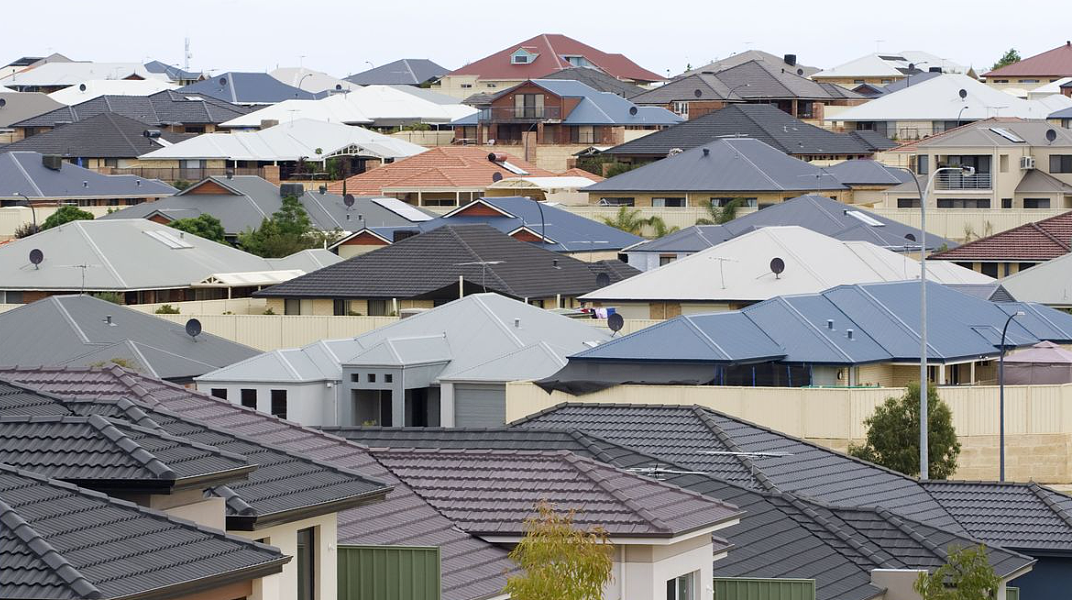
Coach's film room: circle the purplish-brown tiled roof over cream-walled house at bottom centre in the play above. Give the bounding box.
[373,449,741,538]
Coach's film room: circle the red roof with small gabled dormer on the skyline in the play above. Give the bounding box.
[447,33,666,81]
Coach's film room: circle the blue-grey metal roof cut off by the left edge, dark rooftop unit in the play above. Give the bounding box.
[0,148,178,200]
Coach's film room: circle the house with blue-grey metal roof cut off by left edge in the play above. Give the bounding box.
[0,151,178,205]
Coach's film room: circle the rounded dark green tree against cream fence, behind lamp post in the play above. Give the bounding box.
[849,383,961,479]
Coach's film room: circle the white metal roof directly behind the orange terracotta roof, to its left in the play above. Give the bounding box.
[140,119,425,161]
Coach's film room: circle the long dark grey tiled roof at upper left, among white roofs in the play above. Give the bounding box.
[15,90,250,128]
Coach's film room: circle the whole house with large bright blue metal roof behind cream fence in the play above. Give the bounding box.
[542,280,1072,392]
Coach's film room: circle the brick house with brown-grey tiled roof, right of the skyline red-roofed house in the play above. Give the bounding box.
[632,60,866,123]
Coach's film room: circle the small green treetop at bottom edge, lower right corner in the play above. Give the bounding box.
[912,545,1001,600]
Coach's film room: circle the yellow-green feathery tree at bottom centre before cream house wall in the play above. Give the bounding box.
[504,503,613,600]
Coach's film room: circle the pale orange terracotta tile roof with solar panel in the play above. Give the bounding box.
[328,146,555,195]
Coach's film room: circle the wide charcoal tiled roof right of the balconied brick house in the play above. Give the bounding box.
[604,104,894,159]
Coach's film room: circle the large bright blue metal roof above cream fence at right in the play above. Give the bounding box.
[570,282,1072,364]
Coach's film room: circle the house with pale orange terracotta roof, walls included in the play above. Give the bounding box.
[328,146,561,207]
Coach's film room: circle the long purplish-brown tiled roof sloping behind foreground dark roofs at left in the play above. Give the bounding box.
[0,366,516,600]
